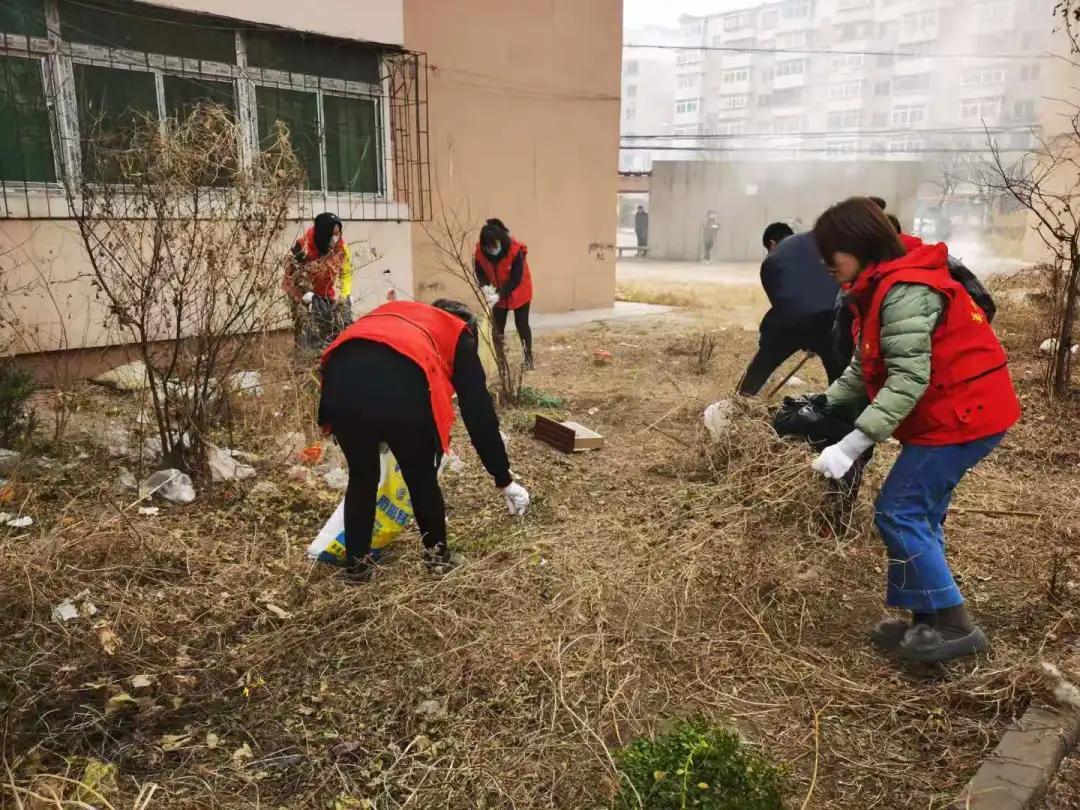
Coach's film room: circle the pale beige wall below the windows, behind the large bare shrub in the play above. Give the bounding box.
[0,220,414,355]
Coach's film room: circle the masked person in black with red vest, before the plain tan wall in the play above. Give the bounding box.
[473,219,532,369]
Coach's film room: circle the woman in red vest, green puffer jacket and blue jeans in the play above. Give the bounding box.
[813,198,1021,661]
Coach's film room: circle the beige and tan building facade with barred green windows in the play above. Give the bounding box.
[0,0,622,365]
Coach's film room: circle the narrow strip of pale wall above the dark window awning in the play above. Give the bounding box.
[146,0,404,45]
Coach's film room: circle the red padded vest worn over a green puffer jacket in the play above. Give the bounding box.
[853,243,1021,445]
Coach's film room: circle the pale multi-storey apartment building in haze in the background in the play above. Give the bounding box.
[623,0,1054,168]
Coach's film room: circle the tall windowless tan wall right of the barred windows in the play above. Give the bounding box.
[405,0,622,311]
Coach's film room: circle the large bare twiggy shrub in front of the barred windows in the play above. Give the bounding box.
[69,105,303,475]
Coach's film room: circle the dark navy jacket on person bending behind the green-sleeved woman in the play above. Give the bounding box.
[761,231,840,332]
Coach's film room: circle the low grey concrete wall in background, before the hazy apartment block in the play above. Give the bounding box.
[649,161,919,261]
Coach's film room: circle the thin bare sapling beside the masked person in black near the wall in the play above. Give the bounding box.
[423,195,525,407]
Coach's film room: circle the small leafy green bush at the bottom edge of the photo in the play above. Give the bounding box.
[615,717,783,810]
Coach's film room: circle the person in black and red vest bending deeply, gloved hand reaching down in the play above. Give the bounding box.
[319,300,529,581]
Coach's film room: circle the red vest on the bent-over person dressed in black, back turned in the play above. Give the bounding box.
[322,301,467,453]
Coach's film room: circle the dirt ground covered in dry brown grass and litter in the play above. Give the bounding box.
[0,270,1080,810]
